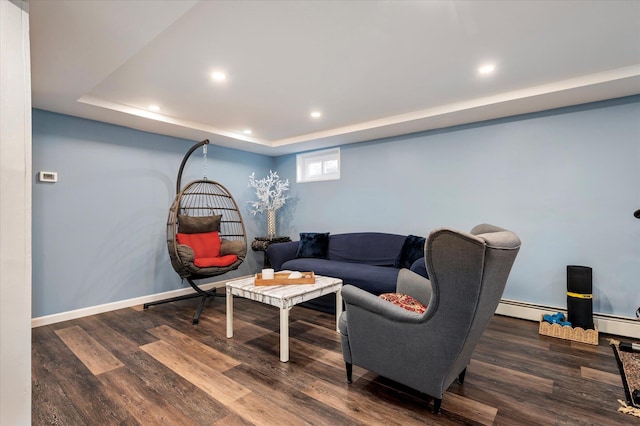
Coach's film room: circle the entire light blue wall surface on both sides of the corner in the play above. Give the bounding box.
[33,96,640,317]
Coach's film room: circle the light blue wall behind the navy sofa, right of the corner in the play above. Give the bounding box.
[276,96,640,316]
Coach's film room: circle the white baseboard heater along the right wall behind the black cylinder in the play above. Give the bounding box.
[496,299,640,339]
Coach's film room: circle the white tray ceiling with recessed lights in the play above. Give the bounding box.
[30,0,640,155]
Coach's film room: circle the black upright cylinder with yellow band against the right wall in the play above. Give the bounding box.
[567,265,593,330]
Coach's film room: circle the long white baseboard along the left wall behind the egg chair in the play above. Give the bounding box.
[31,282,225,328]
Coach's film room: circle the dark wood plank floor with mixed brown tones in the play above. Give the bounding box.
[32,292,639,425]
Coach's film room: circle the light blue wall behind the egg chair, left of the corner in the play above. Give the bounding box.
[33,110,273,317]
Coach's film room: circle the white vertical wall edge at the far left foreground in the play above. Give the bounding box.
[0,0,33,425]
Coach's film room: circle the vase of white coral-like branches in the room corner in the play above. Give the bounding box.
[249,170,290,238]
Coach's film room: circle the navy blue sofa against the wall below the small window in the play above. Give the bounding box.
[267,232,427,313]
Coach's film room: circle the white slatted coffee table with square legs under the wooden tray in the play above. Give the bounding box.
[227,275,342,362]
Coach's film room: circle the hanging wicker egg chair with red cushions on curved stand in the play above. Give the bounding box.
[143,140,247,324]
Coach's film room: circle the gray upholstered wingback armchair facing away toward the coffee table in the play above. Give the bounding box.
[339,224,520,413]
